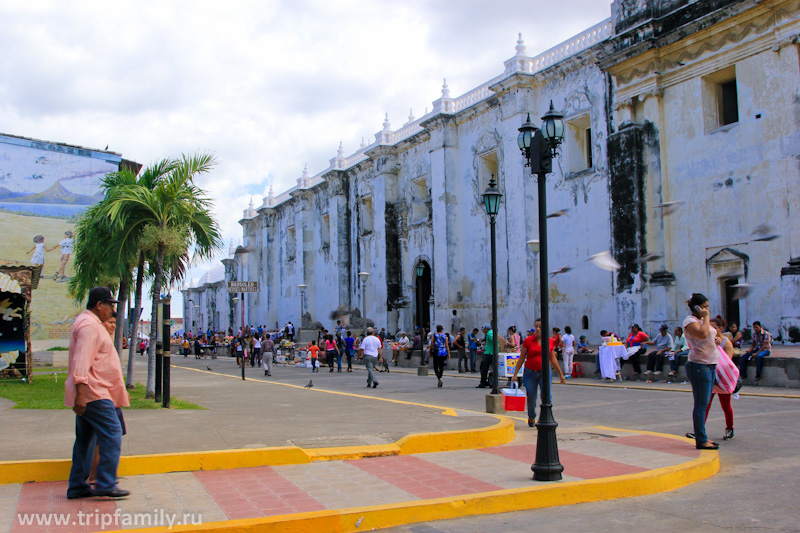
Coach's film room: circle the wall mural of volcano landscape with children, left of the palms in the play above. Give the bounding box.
[0,134,122,340]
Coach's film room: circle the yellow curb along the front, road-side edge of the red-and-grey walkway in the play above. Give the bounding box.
[112,433,719,533]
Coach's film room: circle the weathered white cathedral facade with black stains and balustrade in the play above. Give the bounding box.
[183,0,800,341]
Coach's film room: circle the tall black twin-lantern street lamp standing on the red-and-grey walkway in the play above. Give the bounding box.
[517,100,564,481]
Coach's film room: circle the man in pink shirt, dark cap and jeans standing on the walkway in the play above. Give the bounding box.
[64,287,130,500]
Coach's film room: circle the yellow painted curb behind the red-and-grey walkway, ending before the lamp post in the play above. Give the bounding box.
[0,417,514,485]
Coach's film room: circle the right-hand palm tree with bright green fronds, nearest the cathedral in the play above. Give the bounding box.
[108,154,222,397]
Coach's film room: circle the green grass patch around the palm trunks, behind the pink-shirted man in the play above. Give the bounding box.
[0,369,205,409]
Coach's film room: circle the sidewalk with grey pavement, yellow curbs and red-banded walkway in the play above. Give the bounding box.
[0,361,719,532]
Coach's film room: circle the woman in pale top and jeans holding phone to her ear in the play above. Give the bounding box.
[683,293,719,450]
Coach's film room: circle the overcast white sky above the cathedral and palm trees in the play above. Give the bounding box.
[0,0,611,316]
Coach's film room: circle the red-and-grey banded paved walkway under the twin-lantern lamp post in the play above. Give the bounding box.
[0,427,709,532]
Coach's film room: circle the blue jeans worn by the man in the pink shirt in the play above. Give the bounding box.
[67,400,122,496]
